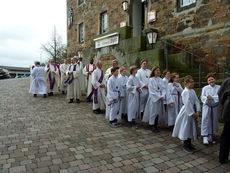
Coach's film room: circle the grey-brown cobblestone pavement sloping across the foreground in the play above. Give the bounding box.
[0,79,230,173]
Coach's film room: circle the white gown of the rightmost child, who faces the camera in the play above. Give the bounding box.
[201,85,220,136]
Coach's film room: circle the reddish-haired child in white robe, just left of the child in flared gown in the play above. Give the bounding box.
[166,73,183,127]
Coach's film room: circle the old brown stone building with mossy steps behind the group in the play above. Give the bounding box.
[67,0,230,73]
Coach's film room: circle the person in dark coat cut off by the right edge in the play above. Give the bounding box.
[218,78,230,164]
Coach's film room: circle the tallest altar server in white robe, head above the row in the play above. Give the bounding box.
[136,60,151,117]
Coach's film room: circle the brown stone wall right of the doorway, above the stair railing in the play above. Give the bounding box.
[147,0,230,63]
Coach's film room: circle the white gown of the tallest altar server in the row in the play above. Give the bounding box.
[136,68,151,112]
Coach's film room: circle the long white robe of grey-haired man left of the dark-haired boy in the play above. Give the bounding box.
[92,68,106,110]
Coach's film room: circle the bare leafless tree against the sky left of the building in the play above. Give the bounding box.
[41,27,67,62]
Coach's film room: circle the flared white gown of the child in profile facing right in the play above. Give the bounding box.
[172,88,200,141]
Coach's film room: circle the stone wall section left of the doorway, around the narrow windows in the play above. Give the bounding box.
[67,0,126,56]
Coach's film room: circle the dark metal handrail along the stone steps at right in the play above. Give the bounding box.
[163,40,230,88]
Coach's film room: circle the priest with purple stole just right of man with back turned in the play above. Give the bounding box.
[45,59,61,96]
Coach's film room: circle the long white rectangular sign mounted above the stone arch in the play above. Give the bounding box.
[93,32,119,49]
